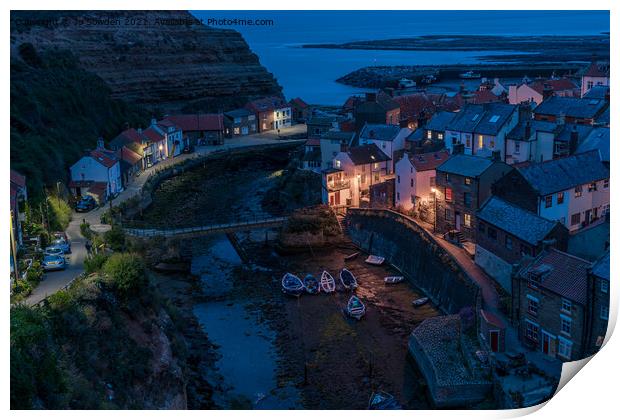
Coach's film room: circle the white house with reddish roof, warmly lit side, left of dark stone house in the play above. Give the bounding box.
[394,150,450,210]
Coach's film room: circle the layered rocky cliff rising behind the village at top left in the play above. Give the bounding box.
[11,11,282,111]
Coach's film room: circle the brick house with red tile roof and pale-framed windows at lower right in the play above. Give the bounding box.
[512,248,609,362]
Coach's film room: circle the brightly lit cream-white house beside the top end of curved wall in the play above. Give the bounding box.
[322,144,391,207]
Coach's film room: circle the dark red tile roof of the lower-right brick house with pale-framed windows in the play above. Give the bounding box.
[521,248,590,305]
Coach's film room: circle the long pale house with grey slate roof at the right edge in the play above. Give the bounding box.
[493,151,609,232]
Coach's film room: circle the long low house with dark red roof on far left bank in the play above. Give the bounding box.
[165,114,224,146]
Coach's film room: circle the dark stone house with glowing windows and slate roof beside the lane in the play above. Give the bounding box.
[435,153,511,242]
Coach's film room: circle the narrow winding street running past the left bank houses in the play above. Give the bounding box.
[24,124,306,305]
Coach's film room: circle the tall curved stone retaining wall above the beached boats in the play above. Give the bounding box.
[345,209,480,314]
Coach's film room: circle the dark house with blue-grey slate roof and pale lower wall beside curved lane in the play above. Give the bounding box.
[475,196,568,294]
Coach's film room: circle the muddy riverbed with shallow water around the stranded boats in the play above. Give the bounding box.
[186,231,439,409]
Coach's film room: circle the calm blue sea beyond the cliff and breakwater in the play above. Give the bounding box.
[192,10,609,105]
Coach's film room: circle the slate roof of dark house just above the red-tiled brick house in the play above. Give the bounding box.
[477,196,558,245]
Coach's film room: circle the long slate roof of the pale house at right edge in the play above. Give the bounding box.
[516,151,609,195]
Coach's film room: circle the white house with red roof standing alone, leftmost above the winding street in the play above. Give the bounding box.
[69,139,123,203]
